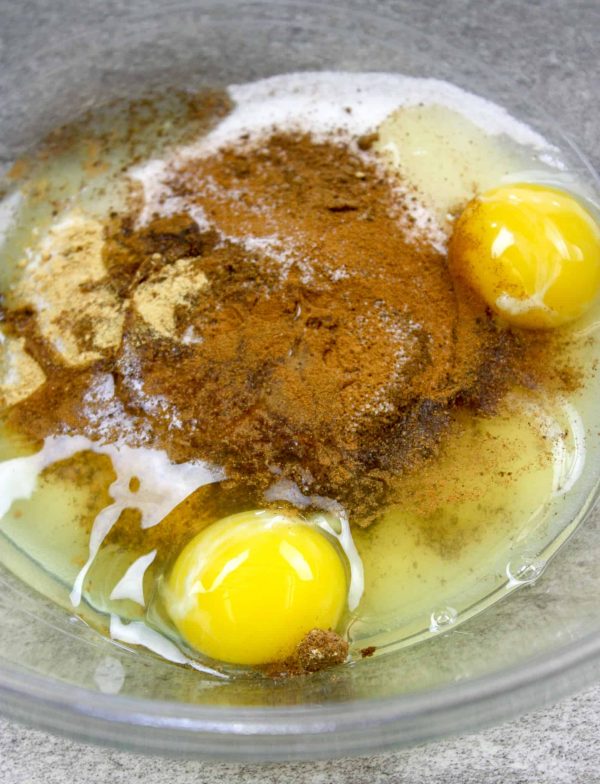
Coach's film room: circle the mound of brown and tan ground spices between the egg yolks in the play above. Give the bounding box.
[5,133,540,524]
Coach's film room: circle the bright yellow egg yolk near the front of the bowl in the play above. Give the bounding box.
[164,510,348,665]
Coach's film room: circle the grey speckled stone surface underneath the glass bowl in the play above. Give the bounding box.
[0,0,600,784]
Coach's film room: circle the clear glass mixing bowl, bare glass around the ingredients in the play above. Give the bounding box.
[0,2,600,760]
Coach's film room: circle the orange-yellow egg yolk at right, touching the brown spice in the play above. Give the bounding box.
[449,184,600,328]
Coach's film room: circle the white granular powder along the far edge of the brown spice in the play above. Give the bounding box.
[130,71,560,254]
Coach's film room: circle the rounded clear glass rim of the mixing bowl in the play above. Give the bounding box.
[0,0,600,761]
